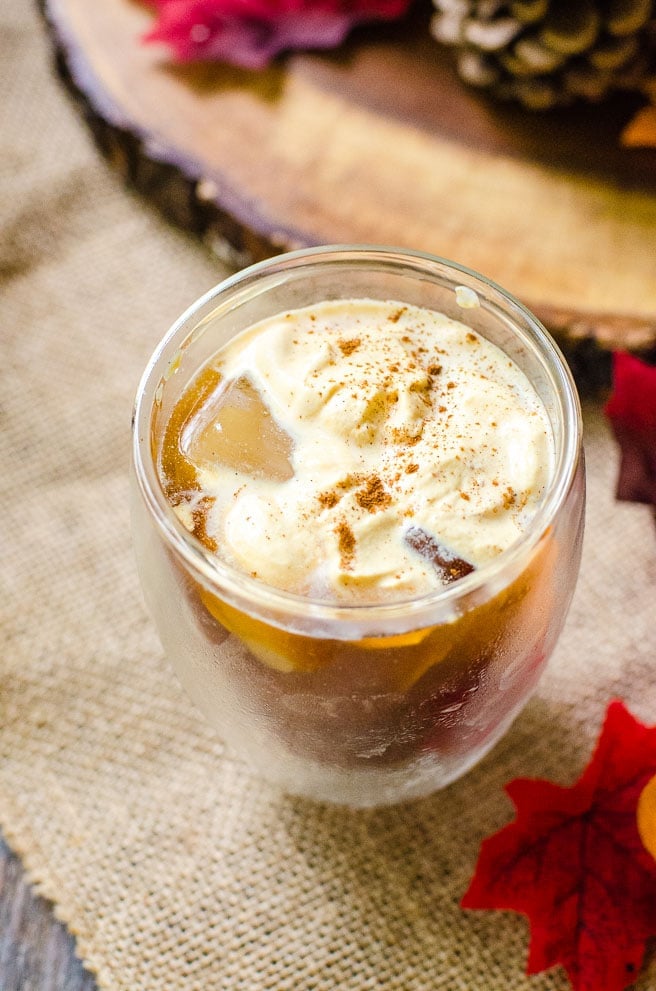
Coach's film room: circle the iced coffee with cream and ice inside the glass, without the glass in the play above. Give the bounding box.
[157,299,556,797]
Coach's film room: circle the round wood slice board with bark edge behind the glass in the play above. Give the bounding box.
[41,0,656,387]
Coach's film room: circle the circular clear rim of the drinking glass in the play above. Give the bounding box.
[132,244,582,639]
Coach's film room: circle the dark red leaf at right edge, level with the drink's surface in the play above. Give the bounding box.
[605,351,656,506]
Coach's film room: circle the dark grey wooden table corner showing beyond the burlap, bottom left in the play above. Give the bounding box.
[0,837,96,991]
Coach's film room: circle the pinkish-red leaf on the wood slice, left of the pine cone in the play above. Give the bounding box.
[144,0,411,69]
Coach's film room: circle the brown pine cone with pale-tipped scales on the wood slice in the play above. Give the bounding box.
[431,0,656,110]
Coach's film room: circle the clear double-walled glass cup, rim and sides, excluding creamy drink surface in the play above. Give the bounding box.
[132,246,585,806]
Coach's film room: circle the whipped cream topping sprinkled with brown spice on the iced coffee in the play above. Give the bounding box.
[176,300,553,602]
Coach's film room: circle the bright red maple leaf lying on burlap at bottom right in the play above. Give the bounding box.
[461,702,656,991]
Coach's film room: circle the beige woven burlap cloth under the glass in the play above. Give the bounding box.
[0,0,656,991]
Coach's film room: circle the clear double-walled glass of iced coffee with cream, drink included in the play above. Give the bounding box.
[133,248,583,805]
